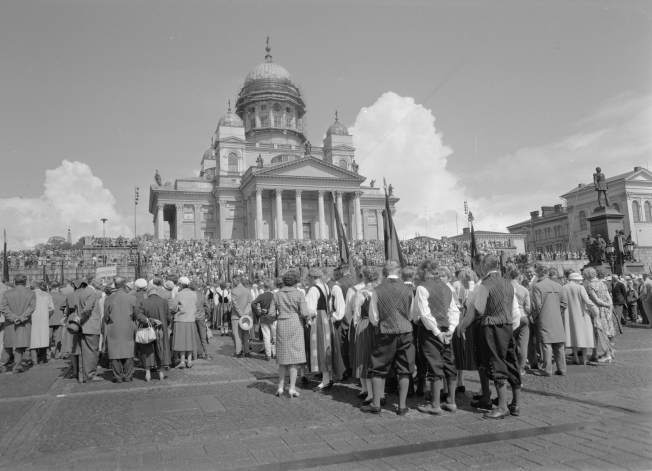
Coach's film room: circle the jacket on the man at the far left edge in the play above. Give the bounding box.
[0,285,36,348]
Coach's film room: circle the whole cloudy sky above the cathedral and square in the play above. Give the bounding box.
[0,0,652,248]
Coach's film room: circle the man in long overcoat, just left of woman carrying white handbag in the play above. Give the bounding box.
[104,276,138,383]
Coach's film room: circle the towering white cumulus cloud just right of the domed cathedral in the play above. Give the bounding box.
[349,92,465,238]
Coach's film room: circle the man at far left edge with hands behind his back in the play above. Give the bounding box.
[0,275,36,373]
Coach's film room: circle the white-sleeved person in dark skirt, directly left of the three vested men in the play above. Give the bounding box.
[351,267,382,405]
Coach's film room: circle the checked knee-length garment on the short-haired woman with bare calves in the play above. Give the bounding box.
[268,286,308,365]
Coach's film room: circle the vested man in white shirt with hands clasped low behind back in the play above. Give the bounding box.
[412,261,460,415]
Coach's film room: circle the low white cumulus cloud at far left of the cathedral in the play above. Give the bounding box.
[0,160,132,249]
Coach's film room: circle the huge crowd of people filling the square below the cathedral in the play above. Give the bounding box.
[0,251,652,419]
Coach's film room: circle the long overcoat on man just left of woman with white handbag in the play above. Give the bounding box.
[104,289,138,360]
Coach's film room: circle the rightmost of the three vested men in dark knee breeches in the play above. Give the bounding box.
[473,254,521,419]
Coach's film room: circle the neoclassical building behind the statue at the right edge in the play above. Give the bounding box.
[507,167,652,252]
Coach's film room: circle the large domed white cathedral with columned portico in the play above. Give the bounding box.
[149,43,398,239]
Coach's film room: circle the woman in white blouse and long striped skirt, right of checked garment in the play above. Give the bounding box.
[306,268,344,392]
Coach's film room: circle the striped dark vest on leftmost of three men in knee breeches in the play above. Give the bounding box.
[375,279,412,334]
